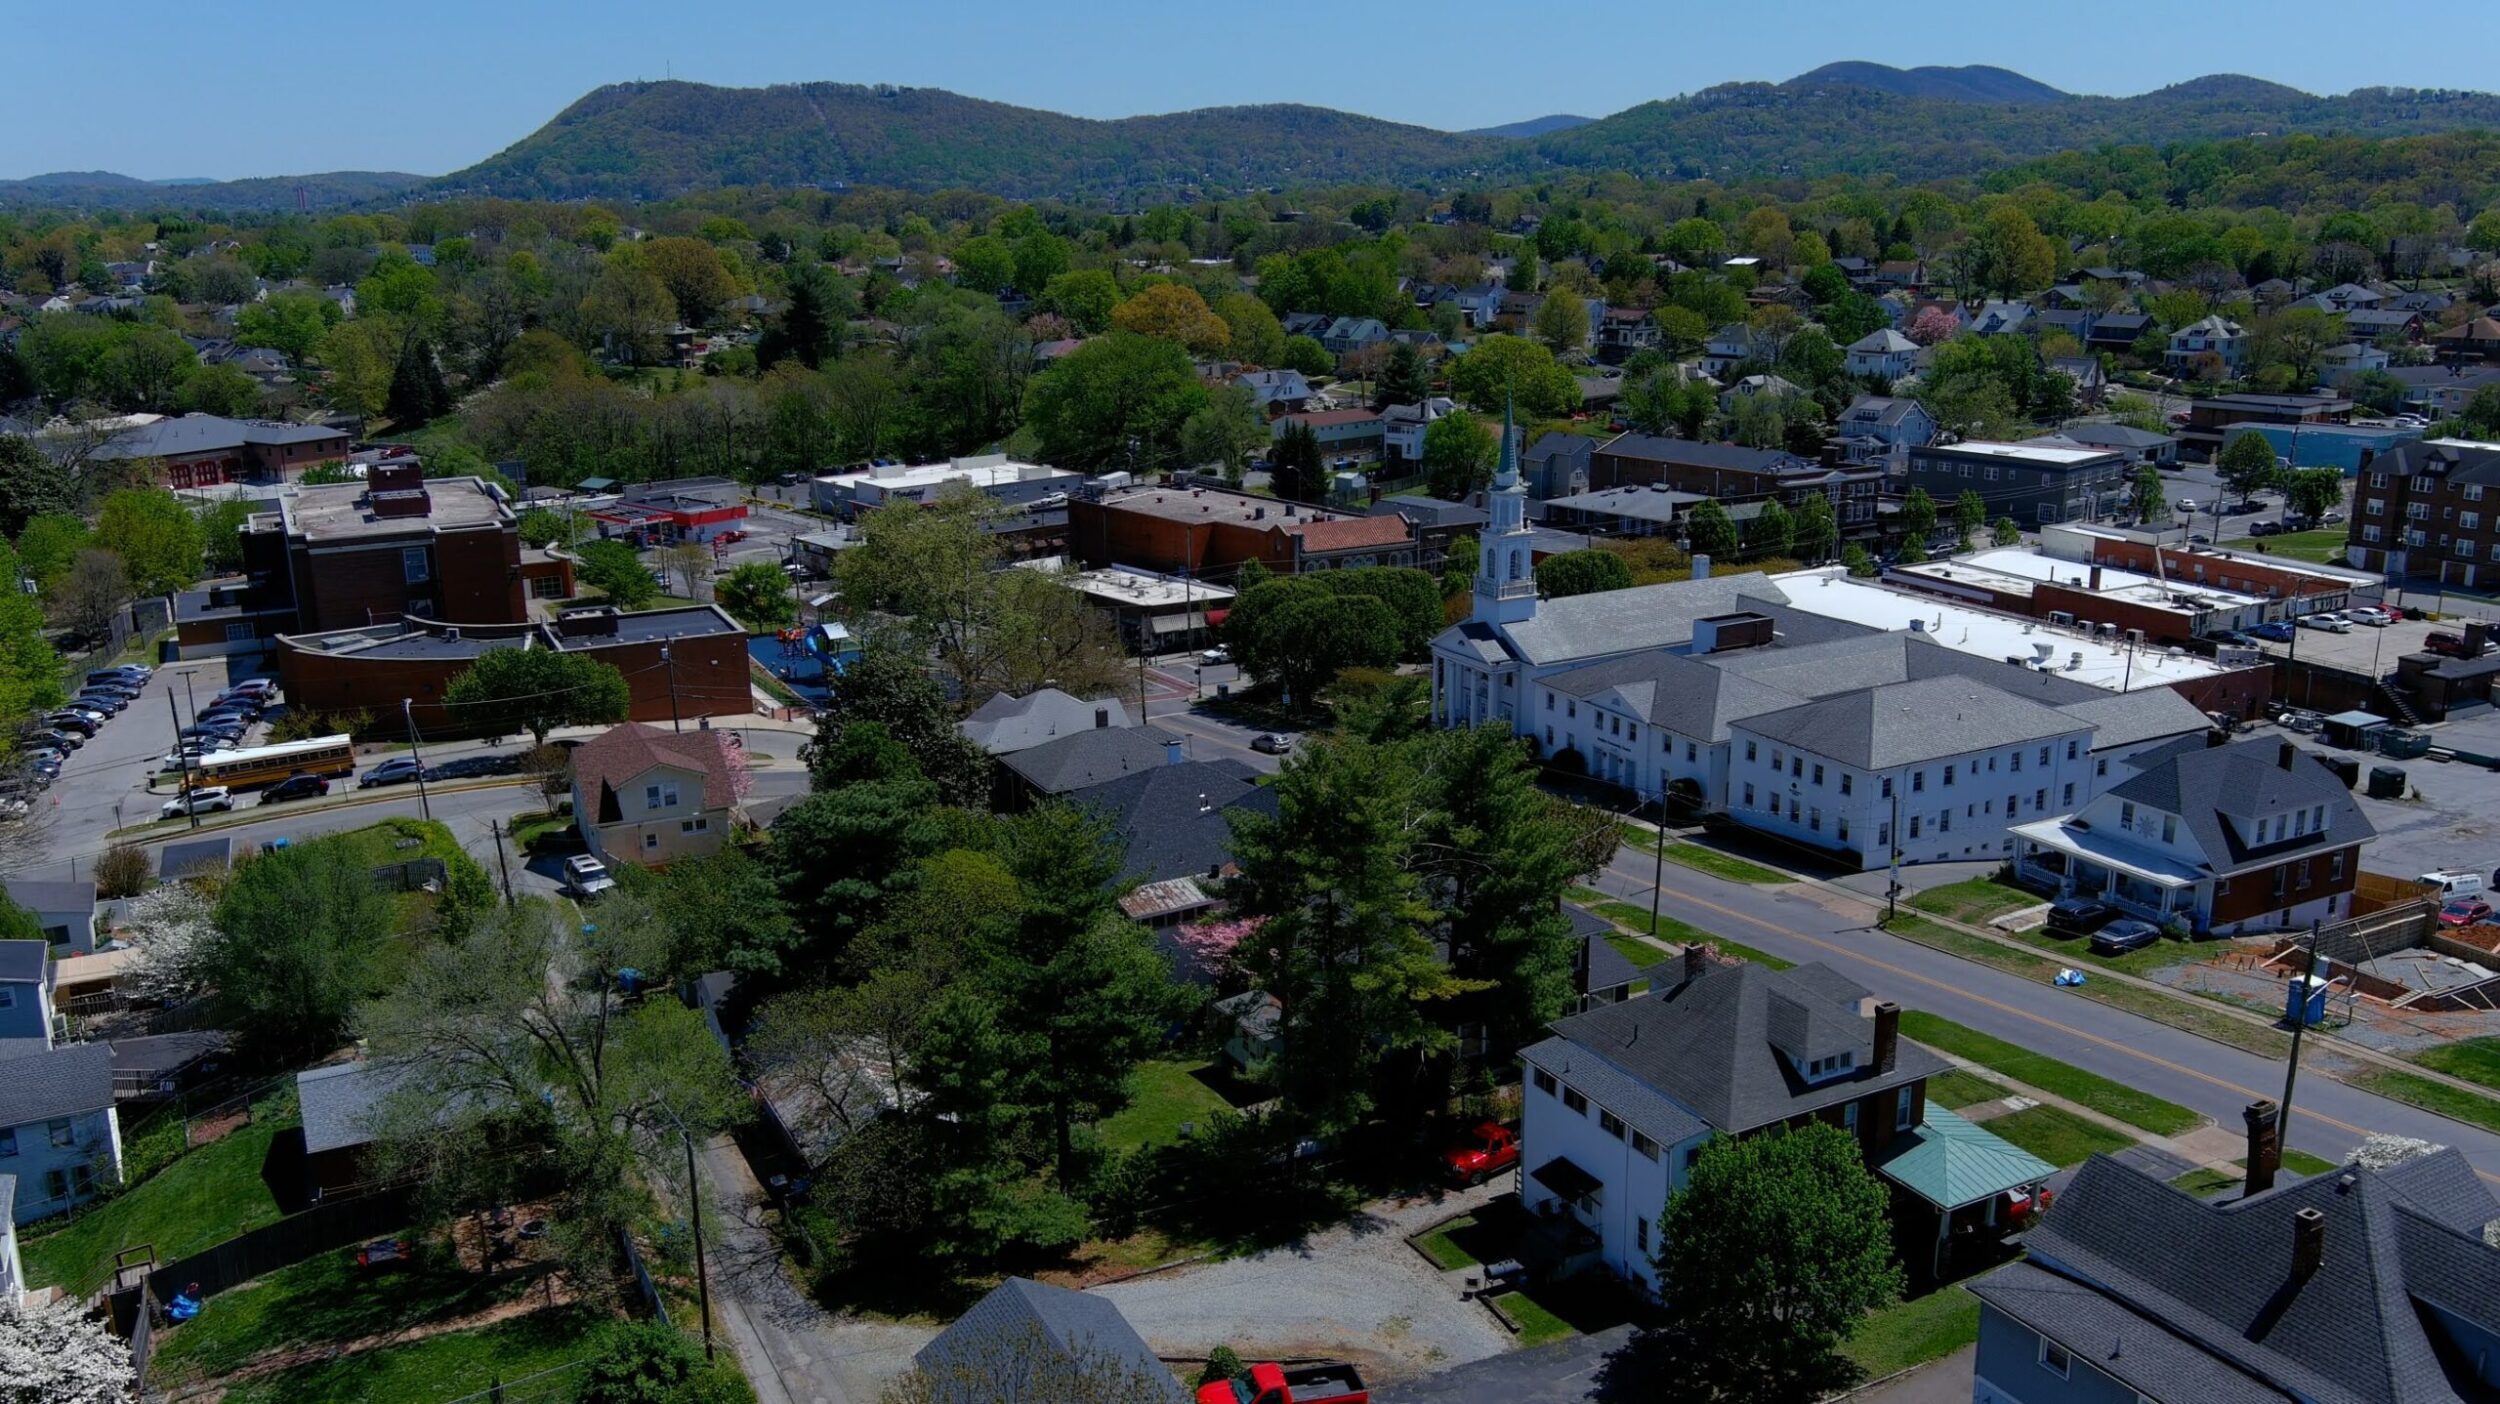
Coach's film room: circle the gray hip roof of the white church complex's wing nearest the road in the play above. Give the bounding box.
[1745,677,2085,769]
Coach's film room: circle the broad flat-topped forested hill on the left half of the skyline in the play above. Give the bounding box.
[438,82,1510,200]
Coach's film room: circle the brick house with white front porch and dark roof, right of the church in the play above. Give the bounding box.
[2013,739,2378,934]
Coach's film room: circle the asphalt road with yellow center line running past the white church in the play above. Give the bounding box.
[1598,834,2500,1179]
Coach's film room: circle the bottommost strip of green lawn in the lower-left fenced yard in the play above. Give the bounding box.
[225,1307,605,1404]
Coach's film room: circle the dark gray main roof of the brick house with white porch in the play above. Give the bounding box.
[2110,737,2378,872]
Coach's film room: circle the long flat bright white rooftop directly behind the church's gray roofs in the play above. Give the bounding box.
[1773,565,2233,692]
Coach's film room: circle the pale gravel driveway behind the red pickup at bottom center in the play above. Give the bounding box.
[1093,1182,1510,1379]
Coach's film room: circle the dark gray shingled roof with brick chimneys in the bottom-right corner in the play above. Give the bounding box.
[1973,1149,2500,1404]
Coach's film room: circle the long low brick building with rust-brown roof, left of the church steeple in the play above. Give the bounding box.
[1068,487,1420,577]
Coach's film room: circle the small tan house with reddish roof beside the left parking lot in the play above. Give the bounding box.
[573,722,743,867]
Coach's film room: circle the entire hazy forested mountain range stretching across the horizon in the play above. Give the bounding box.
[14,62,2500,210]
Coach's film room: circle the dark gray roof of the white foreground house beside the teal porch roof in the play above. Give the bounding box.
[1523,962,1945,1137]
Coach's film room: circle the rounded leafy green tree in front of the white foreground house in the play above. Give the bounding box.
[1658,1114,1903,1404]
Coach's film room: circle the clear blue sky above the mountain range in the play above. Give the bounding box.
[19,0,2500,180]
